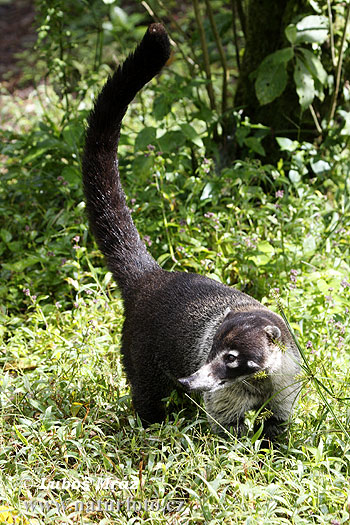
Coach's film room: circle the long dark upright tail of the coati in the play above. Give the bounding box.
[83,24,170,293]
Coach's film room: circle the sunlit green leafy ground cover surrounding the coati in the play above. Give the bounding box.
[0,2,350,525]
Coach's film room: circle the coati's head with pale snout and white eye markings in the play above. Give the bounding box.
[179,310,284,392]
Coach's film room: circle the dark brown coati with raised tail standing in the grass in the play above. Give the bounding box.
[82,24,299,438]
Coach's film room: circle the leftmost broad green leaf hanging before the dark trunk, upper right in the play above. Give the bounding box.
[255,47,293,106]
